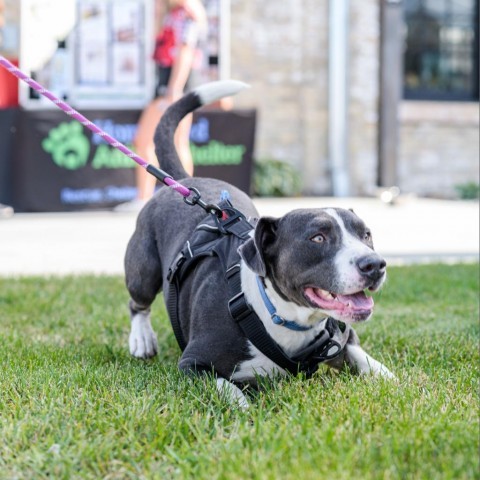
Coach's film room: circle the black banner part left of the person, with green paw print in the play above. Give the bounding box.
[14,110,139,212]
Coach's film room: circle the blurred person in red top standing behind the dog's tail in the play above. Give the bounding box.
[116,0,207,211]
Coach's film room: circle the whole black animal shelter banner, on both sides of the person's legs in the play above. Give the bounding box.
[8,110,255,212]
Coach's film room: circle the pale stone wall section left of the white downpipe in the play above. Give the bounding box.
[231,0,330,193]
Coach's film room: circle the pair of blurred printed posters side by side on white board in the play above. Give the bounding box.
[72,0,154,109]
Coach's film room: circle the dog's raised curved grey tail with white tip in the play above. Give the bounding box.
[154,80,248,180]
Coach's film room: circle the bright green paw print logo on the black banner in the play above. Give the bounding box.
[42,122,90,170]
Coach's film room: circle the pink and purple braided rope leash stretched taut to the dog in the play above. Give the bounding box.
[0,55,190,198]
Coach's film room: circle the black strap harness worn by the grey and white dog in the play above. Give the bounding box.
[167,201,342,376]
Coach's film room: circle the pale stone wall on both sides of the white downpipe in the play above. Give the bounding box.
[231,0,380,195]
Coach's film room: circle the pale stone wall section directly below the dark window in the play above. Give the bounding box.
[398,101,480,198]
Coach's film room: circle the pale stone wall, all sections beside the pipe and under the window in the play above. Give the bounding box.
[231,0,479,197]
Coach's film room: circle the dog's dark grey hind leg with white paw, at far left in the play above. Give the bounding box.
[125,232,162,359]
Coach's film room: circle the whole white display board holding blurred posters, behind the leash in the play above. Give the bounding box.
[20,0,154,109]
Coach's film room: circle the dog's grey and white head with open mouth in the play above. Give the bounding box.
[240,208,386,323]
